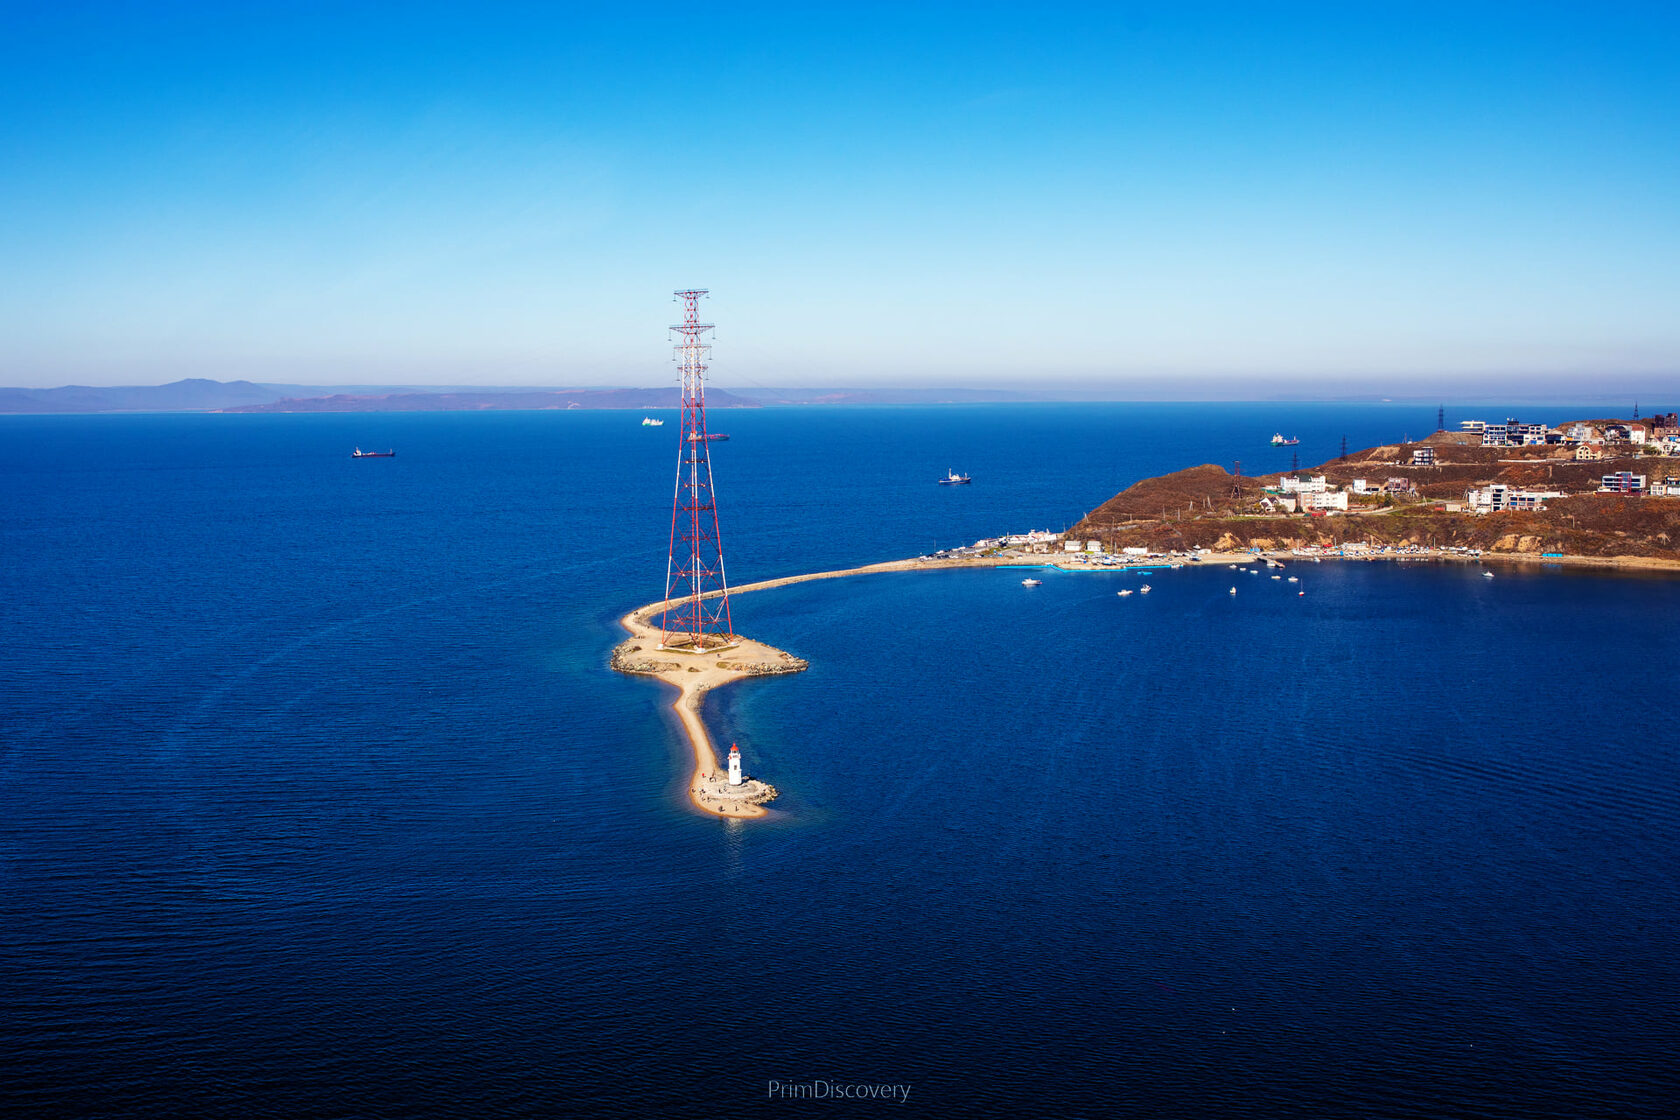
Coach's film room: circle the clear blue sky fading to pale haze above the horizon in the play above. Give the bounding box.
[0,0,1680,386]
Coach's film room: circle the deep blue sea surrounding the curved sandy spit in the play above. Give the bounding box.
[0,405,1680,1118]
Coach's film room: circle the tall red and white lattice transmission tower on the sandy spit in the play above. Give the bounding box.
[659,289,734,652]
